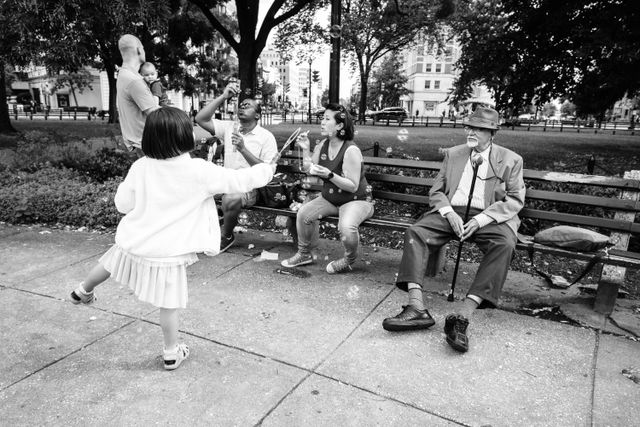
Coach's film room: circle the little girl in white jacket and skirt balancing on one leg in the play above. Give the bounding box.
[71,107,275,370]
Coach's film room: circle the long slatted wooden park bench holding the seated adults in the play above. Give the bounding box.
[253,153,640,314]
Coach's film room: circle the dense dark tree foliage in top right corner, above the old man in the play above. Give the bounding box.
[453,0,640,115]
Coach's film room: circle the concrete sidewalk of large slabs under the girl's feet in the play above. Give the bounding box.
[0,225,640,426]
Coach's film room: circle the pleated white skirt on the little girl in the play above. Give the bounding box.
[98,245,198,308]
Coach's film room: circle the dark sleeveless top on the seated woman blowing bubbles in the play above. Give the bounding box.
[319,140,369,206]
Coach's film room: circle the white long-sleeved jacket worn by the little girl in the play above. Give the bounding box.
[115,153,273,258]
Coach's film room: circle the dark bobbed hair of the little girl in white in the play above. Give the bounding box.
[142,107,194,159]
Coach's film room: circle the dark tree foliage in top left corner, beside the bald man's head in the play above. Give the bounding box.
[0,0,170,132]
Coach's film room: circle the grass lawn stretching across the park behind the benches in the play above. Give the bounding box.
[0,116,640,175]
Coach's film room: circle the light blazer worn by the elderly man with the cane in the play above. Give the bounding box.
[429,144,526,235]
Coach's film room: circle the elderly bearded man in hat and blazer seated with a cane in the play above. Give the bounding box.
[382,107,525,352]
